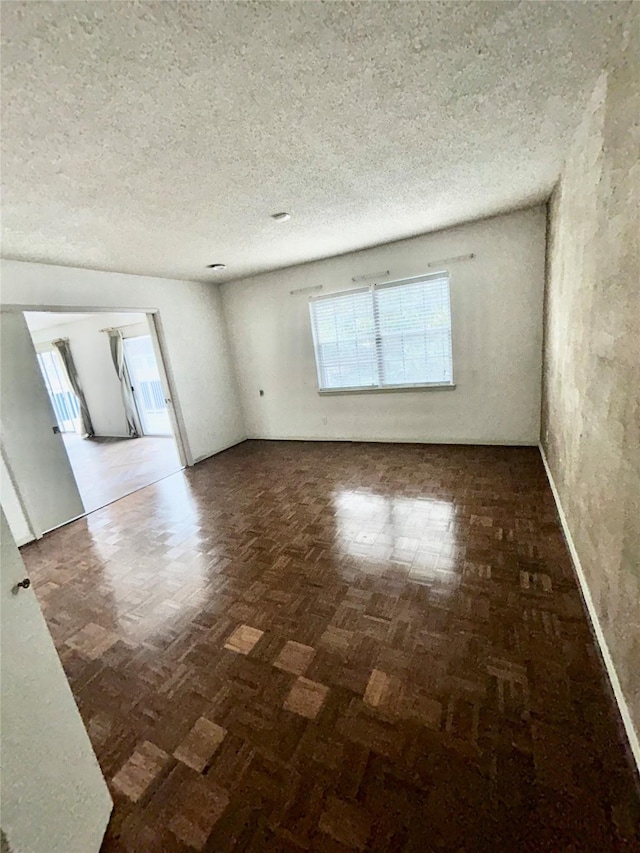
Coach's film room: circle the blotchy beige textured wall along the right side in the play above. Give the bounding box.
[542,20,640,732]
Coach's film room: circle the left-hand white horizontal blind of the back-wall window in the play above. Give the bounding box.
[310,288,378,389]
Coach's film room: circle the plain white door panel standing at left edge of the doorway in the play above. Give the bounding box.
[0,311,84,536]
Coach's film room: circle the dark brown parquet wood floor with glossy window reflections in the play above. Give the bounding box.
[23,441,640,853]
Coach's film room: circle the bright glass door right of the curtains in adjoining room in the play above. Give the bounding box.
[124,335,171,435]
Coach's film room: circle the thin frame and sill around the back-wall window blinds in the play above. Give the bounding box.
[309,270,456,395]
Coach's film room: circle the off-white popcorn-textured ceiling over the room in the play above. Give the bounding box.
[1,2,629,281]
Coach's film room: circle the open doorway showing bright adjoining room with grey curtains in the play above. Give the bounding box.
[24,311,184,512]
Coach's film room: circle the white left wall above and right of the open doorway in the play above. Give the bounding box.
[1,260,245,462]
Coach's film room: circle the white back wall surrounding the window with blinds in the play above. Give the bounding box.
[222,207,546,444]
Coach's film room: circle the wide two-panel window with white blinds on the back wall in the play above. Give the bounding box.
[309,273,453,391]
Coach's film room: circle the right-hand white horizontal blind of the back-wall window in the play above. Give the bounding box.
[374,277,453,385]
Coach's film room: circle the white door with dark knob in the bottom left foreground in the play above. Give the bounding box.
[0,513,112,853]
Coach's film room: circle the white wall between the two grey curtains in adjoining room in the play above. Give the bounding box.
[27,314,149,436]
